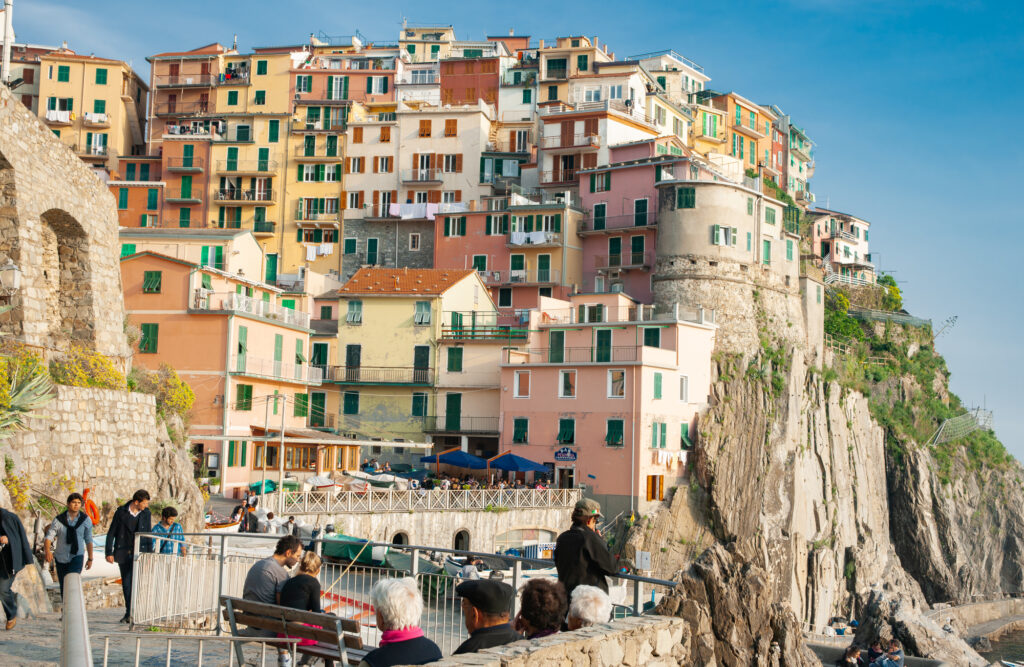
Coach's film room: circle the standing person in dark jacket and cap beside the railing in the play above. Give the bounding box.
[555,498,615,596]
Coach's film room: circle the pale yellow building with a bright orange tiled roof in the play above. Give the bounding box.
[330,268,499,454]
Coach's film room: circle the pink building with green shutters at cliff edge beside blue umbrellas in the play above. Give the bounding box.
[500,293,716,516]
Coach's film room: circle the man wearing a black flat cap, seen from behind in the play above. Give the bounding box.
[455,579,522,654]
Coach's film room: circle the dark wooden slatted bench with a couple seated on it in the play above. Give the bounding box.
[220,595,368,667]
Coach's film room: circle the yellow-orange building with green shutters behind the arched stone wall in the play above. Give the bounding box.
[39,48,150,171]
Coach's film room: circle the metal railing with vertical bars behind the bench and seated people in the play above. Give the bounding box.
[132,533,675,655]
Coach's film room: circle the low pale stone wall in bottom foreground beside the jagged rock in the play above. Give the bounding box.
[419,616,693,667]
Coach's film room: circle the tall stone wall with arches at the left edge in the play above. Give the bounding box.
[0,81,130,370]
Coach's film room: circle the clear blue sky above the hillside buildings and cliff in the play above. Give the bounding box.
[14,0,1024,460]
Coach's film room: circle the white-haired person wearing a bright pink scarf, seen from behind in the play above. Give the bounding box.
[359,577,441,667]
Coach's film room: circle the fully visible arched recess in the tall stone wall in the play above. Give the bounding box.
[36,208,96,347]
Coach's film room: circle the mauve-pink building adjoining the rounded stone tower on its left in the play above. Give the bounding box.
[579,136,716,303]
